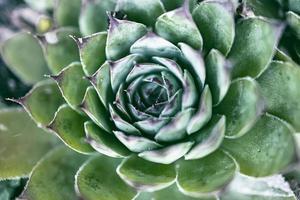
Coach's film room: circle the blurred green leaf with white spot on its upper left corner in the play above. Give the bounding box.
[40,28,80,74]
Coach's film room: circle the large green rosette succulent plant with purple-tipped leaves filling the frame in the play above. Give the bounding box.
[0,0,300,200]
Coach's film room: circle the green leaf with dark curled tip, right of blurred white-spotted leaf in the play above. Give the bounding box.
[74,32,107,76]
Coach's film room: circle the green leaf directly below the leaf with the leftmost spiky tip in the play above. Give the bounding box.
[47,104,93,154]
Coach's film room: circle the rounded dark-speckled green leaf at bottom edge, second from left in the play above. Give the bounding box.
[75,156,137,200]
